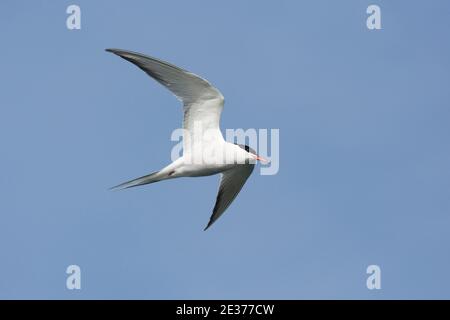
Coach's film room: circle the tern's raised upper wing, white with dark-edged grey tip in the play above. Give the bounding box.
[106,49,224,152]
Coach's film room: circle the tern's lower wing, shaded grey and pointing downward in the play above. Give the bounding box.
[205,164,255,230]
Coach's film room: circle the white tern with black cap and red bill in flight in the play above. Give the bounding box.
[106,49,267,230]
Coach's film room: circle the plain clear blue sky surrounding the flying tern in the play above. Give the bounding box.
[0,0,450,299]
